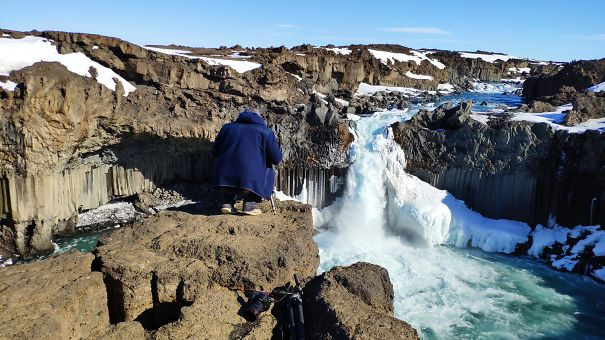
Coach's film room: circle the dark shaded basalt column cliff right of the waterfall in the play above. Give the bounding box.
[393,101,605,226]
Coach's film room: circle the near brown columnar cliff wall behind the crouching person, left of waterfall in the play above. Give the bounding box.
[0,32,352,254]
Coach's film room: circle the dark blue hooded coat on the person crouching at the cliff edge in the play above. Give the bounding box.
[212,111,282,198]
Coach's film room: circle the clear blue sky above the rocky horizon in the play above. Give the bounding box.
[0,0,605,61]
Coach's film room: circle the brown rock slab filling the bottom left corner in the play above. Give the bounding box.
[0,252,109,339]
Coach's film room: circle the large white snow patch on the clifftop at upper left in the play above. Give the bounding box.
[0,36,136,96]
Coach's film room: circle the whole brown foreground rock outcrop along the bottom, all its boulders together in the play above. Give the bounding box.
[0,202,418,339]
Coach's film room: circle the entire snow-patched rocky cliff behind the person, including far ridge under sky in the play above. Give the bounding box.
[0,30,556,255]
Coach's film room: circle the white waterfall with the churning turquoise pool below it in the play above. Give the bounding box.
[314,111,602,339]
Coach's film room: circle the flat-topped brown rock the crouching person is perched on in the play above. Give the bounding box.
[96,202,319,328]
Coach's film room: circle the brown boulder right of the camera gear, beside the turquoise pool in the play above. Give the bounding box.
[303,262,418,339]
